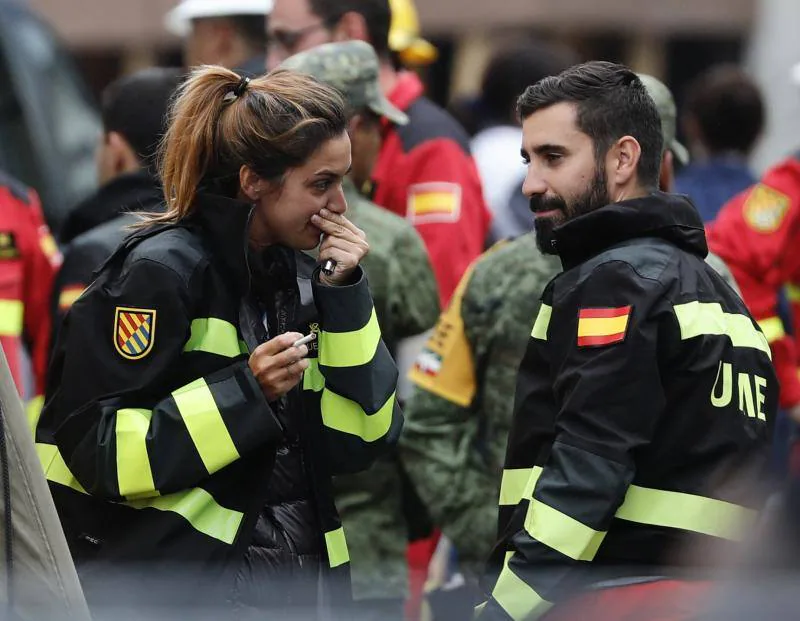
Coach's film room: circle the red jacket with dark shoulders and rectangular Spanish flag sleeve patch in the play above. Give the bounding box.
[372,72,490,308]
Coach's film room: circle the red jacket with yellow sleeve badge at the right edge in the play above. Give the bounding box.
[707,157,800,407]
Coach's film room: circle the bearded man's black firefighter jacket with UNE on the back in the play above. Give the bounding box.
[481,193,778,619]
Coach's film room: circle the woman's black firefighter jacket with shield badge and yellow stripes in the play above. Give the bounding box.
[36,194,402,618]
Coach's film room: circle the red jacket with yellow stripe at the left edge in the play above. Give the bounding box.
[0,173,60,396]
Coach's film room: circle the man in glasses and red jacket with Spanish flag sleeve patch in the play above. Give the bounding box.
[267,0,490,305]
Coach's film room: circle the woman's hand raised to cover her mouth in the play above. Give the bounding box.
[311,209,369,285]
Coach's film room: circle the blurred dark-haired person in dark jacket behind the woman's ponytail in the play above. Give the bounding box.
[53,68,183,332]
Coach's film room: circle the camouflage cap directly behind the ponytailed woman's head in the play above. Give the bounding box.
[280,41,408,125]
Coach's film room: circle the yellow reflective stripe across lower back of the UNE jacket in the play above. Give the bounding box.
[616,485,758,539]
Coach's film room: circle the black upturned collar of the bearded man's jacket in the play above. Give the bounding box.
[553,192,708,270]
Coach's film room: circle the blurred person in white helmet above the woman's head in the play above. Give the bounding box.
[164,0,272,76]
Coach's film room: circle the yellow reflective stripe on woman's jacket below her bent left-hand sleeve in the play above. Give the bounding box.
[122,487,244,544]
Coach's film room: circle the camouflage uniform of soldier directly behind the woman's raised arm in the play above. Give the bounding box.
[334,180,440,599]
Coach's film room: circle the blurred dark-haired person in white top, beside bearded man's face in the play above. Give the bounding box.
[470,39,578,243]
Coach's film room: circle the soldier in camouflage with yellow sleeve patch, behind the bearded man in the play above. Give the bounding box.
[400,69,735,596]
